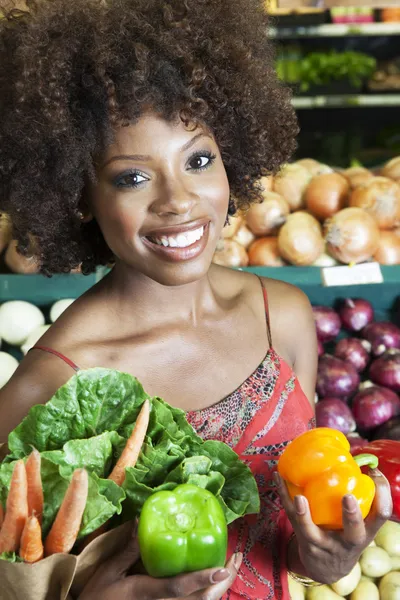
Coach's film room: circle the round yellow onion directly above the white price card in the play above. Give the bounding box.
[325,208,379,263]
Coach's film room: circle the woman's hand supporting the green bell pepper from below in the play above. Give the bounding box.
[78,531,242,600]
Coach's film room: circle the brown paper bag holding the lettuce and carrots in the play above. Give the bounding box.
[0,523,132,600]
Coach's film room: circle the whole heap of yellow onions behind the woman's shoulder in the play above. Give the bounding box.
[214,157,400,267]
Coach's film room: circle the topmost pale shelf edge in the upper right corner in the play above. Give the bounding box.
[268,23,400,39]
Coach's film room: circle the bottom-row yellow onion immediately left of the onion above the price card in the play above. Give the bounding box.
[278,212,324,266]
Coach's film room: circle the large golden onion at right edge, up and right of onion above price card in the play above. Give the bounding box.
[350,177,400,229]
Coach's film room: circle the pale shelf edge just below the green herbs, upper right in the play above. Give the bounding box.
[292,94,400,110]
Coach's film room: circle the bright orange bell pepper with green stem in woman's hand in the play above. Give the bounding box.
[278,427,378,529]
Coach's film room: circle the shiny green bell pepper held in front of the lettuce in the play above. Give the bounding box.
[138,483,228,577]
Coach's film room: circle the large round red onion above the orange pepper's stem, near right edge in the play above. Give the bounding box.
[352,385,400,432]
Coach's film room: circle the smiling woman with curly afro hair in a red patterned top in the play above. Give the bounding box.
[0,0,391,600]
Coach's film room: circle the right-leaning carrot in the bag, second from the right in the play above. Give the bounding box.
[44,469,89,556]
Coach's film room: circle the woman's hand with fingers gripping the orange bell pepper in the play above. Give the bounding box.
[276,469,393,584]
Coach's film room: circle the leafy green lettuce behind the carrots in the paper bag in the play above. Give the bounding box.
[0,369,260,560]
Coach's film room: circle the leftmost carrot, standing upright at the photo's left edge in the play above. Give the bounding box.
[0,460,28,554]
